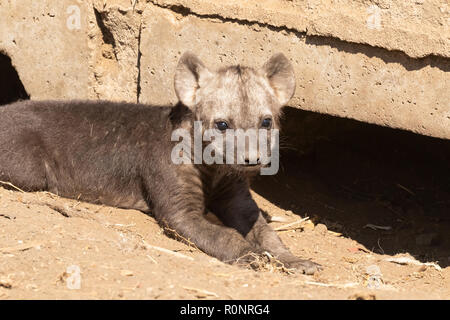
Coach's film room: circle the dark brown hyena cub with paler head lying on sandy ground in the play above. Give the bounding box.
[0,53,318,274]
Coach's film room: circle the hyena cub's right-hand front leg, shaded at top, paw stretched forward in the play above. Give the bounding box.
[213,181,320,274]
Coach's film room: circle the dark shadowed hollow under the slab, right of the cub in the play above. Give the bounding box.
[252,108,450,267]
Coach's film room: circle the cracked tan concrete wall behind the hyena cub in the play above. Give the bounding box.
[0,0,450,139]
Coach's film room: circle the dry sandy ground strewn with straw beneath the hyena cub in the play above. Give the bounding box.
[0,182,450,299]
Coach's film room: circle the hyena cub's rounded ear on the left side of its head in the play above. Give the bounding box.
[175,52,212,107]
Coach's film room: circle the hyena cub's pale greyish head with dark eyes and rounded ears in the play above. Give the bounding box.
[175,53,295,175]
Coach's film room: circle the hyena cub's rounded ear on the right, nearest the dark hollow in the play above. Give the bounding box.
[262,53,295,106]
